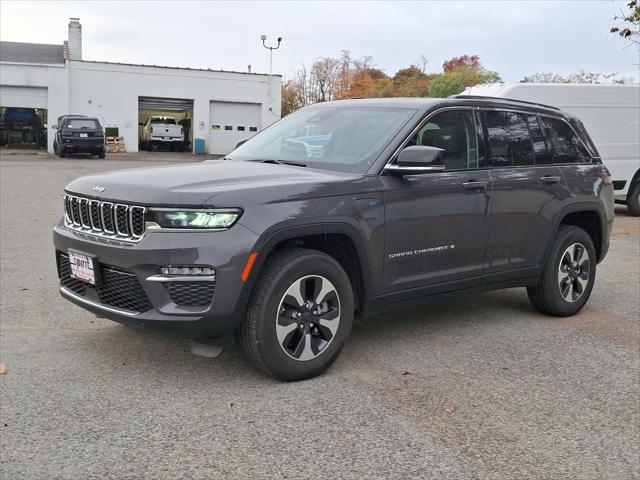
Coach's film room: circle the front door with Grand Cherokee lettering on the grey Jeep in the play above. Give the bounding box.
[381,109,491,293]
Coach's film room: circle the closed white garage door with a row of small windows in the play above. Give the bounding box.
[209,102,262,155]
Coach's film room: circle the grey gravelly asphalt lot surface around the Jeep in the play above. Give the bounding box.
[0,154,640,480]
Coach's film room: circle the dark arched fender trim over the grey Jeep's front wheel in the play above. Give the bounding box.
[238,222,372,311]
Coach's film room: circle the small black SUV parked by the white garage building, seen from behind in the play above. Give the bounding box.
[53,115,106,158]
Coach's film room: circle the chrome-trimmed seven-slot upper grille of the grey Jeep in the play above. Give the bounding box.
[64,195,146,241]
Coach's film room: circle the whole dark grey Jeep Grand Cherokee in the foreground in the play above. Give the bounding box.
[54,96,613,380]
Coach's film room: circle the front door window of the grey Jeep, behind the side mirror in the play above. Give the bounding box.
[407,110,478,170]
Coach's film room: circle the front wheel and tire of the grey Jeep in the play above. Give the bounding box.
[236,248,354,381]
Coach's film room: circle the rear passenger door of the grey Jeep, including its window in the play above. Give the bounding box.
[483,110,569,283]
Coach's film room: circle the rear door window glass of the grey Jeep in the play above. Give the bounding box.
[484,110,533,168]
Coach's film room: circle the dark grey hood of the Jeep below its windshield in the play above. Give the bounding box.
[66,160,371,207]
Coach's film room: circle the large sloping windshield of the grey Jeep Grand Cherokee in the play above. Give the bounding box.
[227,107,416,172]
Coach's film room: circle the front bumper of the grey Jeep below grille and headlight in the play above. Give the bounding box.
[53,222,257,338]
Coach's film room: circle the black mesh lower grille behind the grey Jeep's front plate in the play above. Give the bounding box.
[57,252,153,313]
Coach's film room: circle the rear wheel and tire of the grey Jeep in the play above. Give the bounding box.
[527,225,596,317]
